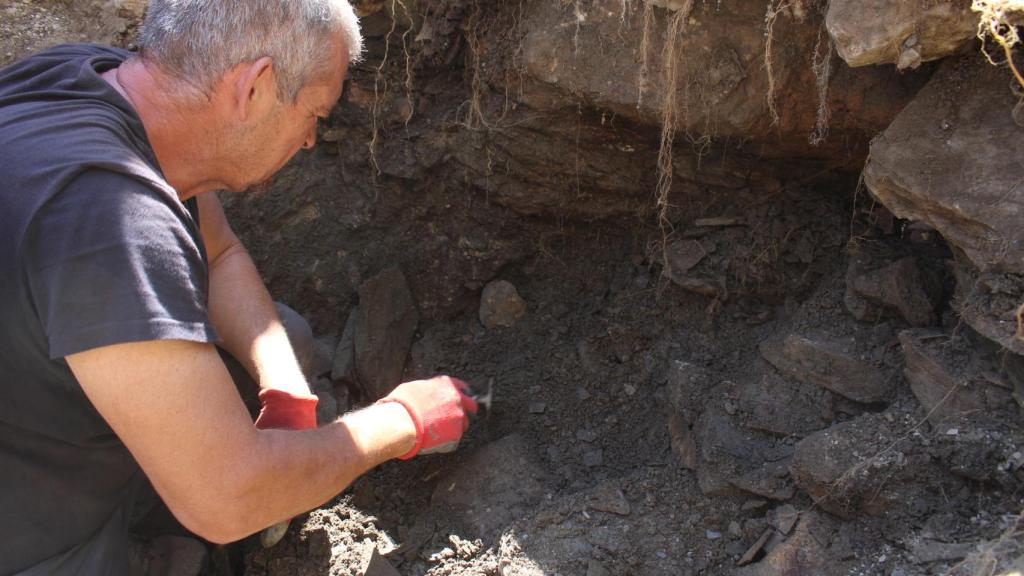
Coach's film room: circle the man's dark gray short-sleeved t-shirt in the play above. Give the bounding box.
[0,45,216,574]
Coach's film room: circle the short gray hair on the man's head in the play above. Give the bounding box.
[139,0,362,102]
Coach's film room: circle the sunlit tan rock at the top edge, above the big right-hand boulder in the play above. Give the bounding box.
[825,0,978,70]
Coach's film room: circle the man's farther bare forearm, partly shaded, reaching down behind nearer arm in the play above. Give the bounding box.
[198,193,309,395]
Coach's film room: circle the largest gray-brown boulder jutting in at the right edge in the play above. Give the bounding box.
[863,56,1024,344]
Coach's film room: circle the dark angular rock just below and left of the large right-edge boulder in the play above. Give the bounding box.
[846,256,942,326]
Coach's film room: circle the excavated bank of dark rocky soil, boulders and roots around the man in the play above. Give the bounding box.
[8,0,1024,576]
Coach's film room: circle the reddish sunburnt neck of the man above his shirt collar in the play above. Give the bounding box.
[103,58,230,201]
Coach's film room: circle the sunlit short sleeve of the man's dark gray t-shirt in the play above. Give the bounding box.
[20,170,217,359]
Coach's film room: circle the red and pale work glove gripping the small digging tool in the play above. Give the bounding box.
[378,376,476,460]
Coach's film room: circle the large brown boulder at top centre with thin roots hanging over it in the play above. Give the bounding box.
[522,0,925,156]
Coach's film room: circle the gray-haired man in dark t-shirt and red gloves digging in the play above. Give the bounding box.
[0,0,475,574]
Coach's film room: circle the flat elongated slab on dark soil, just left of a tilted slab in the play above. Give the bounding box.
[760,334,895,404]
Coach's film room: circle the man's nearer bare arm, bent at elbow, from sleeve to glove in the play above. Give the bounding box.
[67,340,416,542]
